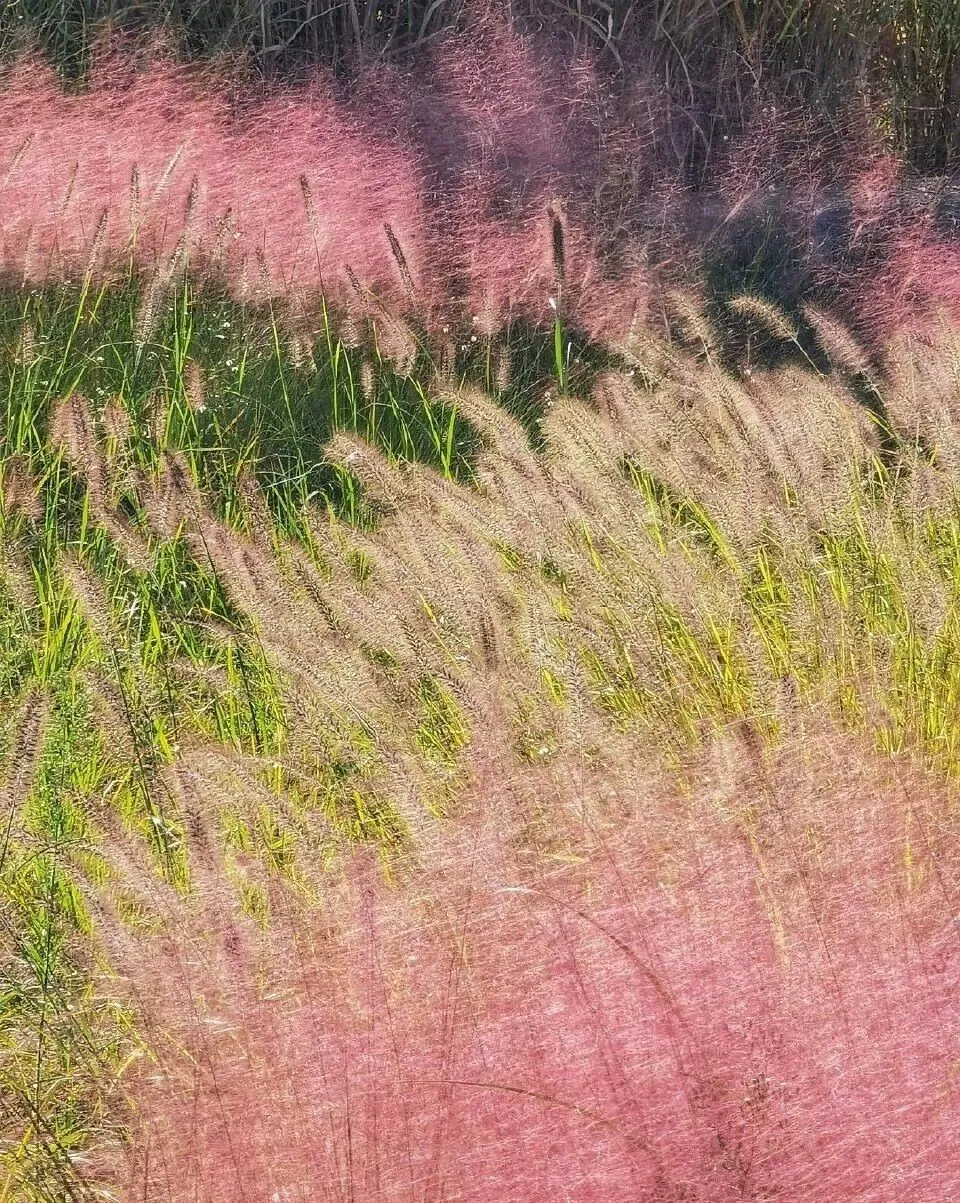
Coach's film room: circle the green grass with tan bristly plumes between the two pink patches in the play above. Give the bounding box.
[1,263,960,1198]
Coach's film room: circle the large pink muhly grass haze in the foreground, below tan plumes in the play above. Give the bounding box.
[101,736,960,1203]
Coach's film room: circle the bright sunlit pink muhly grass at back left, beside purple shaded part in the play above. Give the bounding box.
[0,52,435,310]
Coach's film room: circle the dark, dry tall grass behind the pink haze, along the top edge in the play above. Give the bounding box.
[0,0,960,172]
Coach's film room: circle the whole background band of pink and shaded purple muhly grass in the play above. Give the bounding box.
[0,32,960,348]
